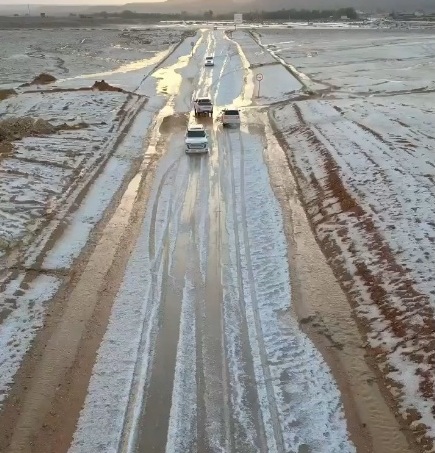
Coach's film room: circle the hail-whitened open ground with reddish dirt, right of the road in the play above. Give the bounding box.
[244,30,435,449]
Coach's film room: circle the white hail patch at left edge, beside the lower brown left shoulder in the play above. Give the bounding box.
[0,275,60,407]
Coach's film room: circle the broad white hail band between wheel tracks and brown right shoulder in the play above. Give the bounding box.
[224,124,355,453]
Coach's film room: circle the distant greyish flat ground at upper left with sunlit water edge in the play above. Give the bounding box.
[0,26,185,88]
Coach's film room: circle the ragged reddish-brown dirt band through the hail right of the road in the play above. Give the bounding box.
[270,104,435,451]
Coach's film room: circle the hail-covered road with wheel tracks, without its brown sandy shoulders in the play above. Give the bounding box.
[67,31,355,453]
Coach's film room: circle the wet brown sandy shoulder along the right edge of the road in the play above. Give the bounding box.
[266,114,418,453]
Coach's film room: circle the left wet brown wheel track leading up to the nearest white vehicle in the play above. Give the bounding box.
[136,153,203,452]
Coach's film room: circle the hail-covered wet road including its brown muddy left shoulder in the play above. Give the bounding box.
[3,30,414,453]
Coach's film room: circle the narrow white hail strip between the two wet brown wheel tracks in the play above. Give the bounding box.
[166,156,208,453]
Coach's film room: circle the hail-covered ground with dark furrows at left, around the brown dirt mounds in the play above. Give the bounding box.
[0,92,126,251]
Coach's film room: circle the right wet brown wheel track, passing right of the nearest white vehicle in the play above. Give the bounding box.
[197,121,232,452]
